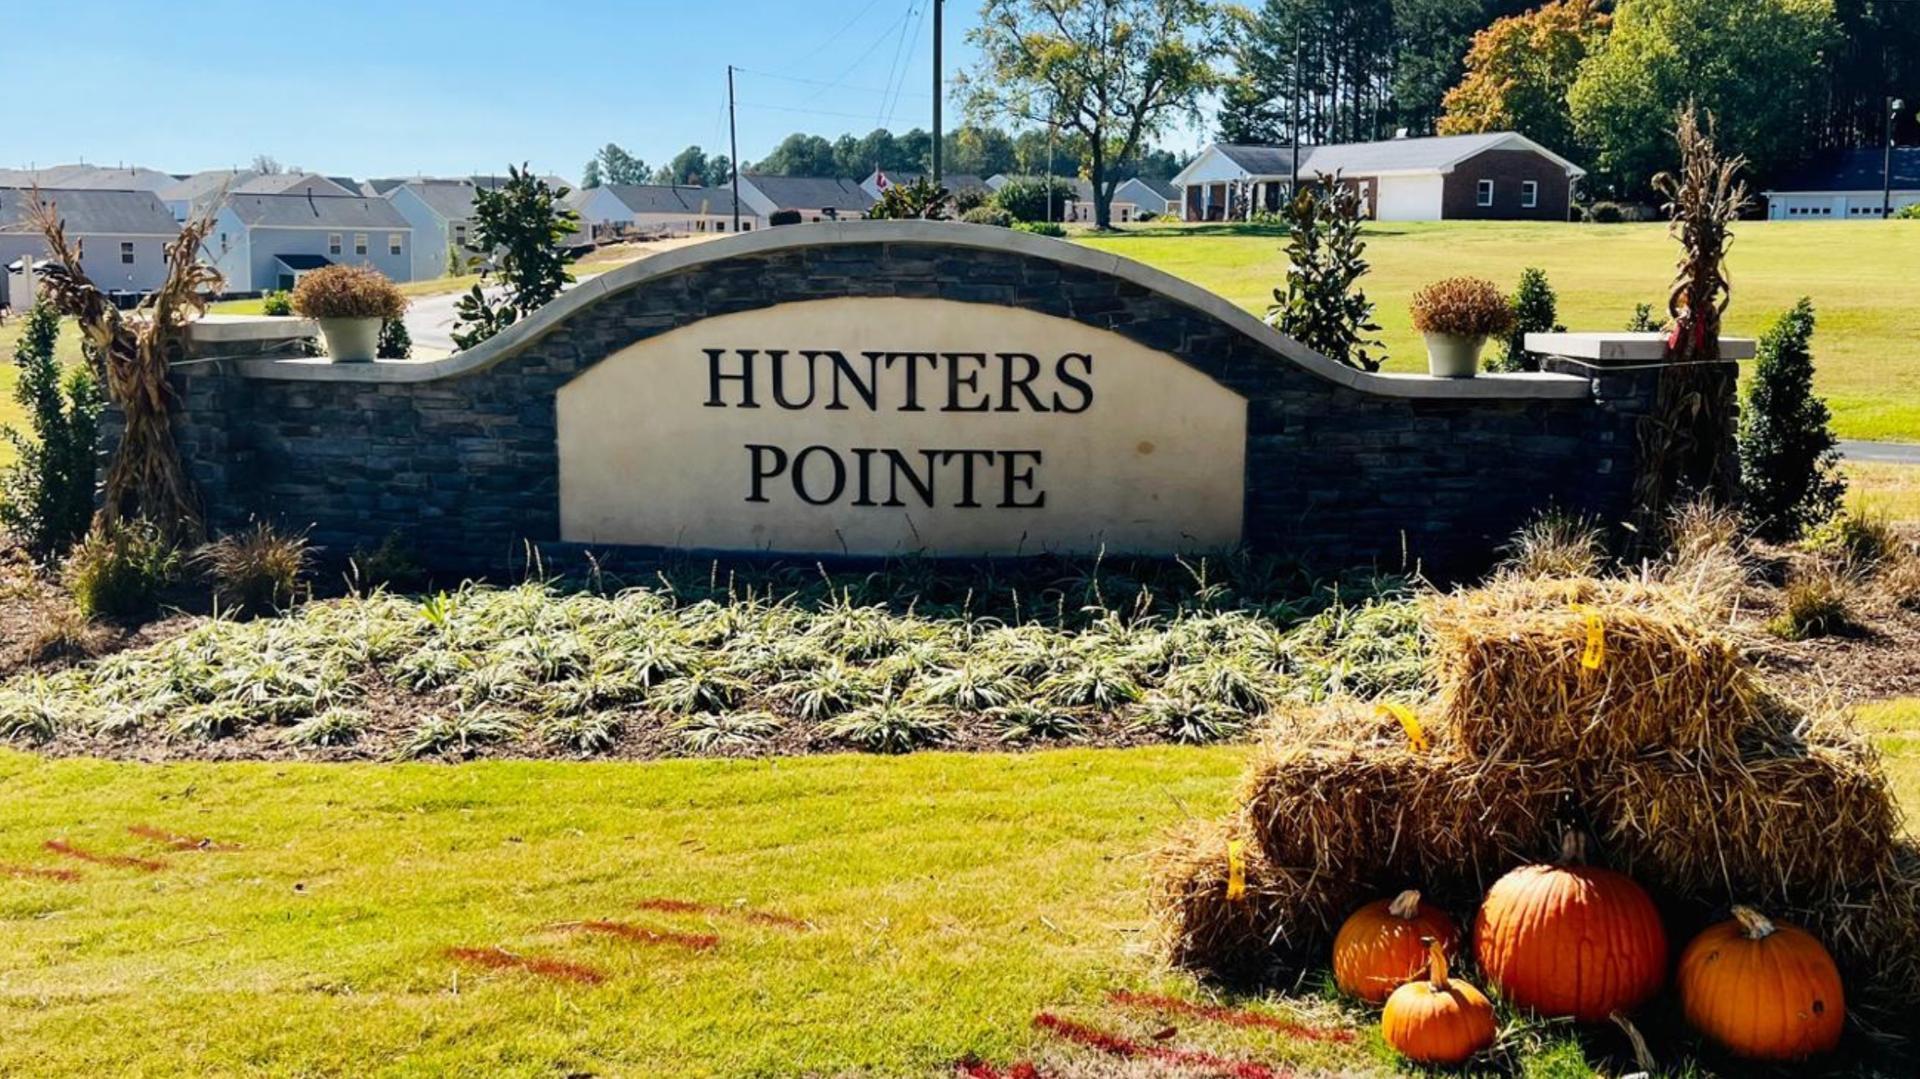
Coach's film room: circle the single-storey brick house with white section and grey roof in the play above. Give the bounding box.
[1173,131,1586,221]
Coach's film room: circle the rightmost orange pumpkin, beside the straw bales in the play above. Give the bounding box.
[1676,906,1847,1060]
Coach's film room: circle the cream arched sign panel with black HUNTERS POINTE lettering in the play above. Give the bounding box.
[557,298,1246,555]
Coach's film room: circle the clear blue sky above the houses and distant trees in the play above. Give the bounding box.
[0,0,1121,179]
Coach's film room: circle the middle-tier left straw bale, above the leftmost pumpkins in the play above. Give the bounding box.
[1240,707,1571,900]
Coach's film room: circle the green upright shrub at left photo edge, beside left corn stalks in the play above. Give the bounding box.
[0,303,102,559]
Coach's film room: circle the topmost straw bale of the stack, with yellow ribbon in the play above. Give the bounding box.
[1427,580,1766,760]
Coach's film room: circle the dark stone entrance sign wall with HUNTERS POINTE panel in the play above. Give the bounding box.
[175,221,1681,576]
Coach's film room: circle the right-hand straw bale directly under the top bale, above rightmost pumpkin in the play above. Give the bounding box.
[1582,728,1901,904]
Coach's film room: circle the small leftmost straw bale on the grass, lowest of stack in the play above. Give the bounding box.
[1148,814,1354,979]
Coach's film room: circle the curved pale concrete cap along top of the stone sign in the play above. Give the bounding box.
[238,221,1590,399]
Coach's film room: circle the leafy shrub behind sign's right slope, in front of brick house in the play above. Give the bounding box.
[1267,175,1386,371]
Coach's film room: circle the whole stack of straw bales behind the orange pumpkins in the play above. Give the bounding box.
[1154,578,1920,1031]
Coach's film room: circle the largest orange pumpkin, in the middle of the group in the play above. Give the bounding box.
[1475,835,1667,1023]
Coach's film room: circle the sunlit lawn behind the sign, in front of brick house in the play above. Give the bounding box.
[1081,221,1920,442]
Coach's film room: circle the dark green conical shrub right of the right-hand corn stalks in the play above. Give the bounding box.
[1740,298,1847,540]
